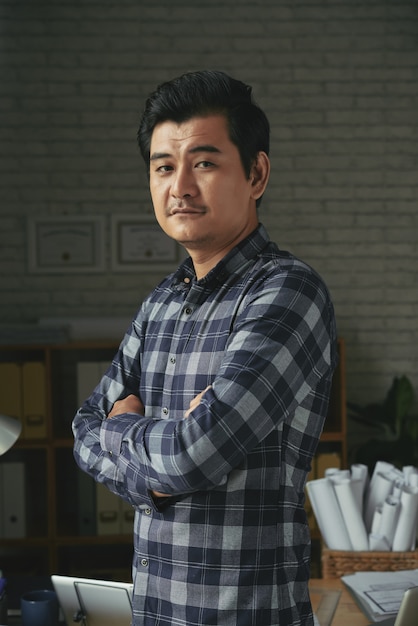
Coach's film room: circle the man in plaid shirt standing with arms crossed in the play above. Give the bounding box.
[74,71,336,626]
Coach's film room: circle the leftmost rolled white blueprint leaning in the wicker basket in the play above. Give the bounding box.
[306,478,353,550]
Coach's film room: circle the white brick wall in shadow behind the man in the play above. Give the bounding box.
[0,0,418,420]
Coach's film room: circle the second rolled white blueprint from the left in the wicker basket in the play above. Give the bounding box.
[333,478,369,550]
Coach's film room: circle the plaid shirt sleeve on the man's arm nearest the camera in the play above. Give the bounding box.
[74,270,336,505]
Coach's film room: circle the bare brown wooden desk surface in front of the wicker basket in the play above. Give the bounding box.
[309,578,370,626]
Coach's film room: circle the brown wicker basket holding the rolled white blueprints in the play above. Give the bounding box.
[321,546,418,578]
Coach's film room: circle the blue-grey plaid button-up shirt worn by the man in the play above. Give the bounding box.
[74,226,336,626]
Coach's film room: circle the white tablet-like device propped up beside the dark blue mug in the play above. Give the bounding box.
[51,574,133,626]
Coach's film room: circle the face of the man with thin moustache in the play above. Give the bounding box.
[150,115,267,260]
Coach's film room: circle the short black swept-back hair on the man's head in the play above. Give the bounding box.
[138,70,270,177]
